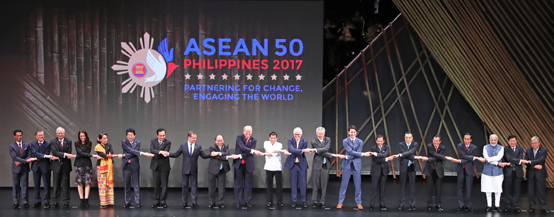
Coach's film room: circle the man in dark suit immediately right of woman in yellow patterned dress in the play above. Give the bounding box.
[121,128,154,208]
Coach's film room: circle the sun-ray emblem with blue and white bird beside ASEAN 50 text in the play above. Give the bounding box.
[112,33,179,103]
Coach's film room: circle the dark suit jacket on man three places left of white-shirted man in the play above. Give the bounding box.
[169,142,211,175]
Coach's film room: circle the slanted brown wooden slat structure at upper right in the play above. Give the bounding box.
[393,0,554,188]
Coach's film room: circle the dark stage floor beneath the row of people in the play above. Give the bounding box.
[0,176,554,217]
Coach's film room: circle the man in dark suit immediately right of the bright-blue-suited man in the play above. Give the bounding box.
[369,135,394,211]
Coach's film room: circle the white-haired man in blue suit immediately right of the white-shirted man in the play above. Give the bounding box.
[285,127,314,208]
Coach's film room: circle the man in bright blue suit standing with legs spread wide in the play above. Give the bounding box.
[337,125,370,210]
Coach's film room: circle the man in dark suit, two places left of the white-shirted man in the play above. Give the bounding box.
[208,135,238,209]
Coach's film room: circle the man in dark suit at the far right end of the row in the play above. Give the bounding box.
[521,136,550,214]
